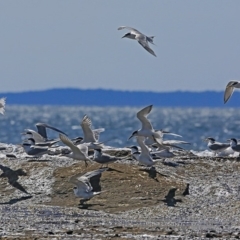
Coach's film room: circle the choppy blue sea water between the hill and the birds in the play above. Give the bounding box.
[0,105,240,151]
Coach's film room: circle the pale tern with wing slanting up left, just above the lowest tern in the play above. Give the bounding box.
[59,133,92,167]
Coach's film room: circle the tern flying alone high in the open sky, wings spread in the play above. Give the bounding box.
[118,26,156,57]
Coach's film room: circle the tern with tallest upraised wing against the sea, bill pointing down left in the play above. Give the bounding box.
[128,105,162,144]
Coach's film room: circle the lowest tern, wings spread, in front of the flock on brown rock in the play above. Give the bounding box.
[70,168,108,204]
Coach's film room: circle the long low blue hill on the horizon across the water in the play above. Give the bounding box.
[0,88,240,107]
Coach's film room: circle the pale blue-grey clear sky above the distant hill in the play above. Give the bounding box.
[0,0,240,92]
